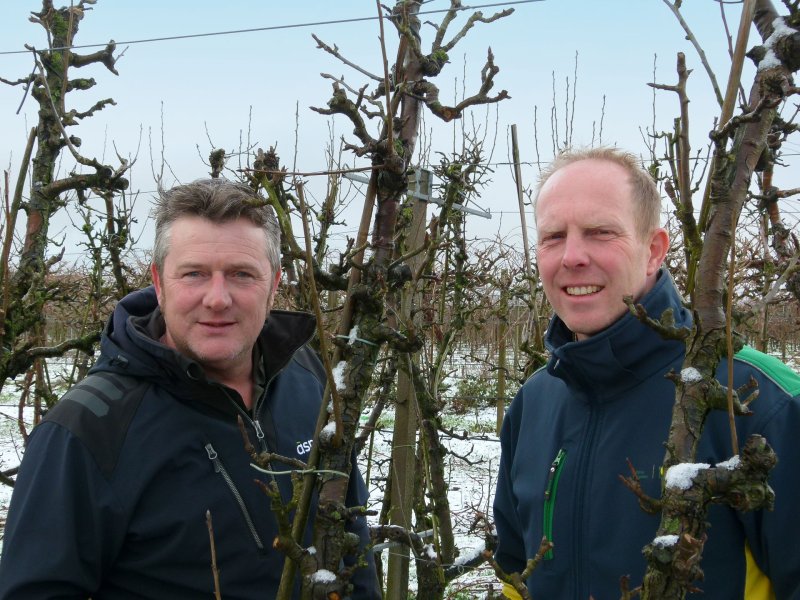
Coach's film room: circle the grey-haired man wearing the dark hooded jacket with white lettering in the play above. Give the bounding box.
[0,180,380,600]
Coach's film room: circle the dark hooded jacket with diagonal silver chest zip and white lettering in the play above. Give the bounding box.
[0,288,380,600]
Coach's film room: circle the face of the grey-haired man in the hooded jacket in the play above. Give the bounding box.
[151,216,280,380]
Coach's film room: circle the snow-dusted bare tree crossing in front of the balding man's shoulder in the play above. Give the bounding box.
[627,0,800,598]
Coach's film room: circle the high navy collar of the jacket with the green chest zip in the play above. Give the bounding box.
[545,267,692,400]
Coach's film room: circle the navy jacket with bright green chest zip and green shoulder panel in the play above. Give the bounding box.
[494,271,800,600]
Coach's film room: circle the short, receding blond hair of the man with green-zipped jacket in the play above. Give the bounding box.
[534,146,661,239]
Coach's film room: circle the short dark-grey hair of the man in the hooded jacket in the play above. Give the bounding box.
[153,179,281,273]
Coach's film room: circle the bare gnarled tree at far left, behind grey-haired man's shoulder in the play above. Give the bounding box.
[0,0,138,458]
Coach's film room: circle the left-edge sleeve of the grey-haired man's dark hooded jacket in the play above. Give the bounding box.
[0,422,123,600]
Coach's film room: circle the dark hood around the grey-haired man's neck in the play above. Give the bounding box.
[92,286,316,408]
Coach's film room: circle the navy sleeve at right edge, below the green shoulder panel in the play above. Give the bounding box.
[742,374,800,600]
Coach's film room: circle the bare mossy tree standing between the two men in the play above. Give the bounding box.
[234,0,511,598]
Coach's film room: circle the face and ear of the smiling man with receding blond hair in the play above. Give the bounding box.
[536,159,669,339]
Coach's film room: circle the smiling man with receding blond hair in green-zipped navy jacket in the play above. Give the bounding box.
[494,149,800,600]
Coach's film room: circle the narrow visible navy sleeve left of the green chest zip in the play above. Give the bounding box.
[494,391,526,573]
